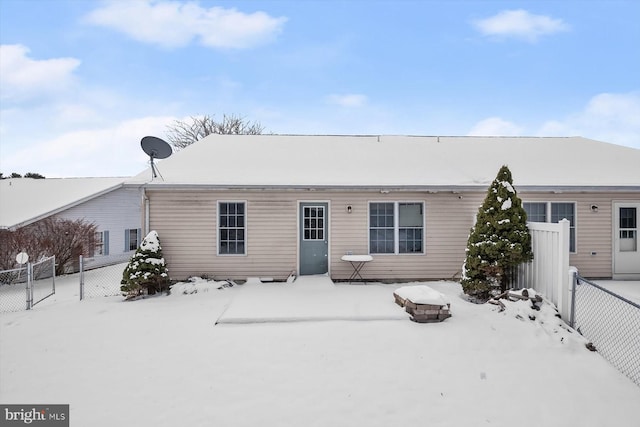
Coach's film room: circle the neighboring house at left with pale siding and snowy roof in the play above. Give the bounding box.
[0,178,142,267]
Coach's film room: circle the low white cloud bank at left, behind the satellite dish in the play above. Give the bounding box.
[2,117,175,178]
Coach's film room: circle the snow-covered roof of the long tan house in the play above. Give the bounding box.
[129,135,640,189]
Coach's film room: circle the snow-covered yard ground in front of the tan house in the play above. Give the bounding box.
[0,277,640,427]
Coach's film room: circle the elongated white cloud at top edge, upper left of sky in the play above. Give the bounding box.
[86,0,287,48]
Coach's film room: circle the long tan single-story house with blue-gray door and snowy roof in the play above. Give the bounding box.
[127,135,640,280]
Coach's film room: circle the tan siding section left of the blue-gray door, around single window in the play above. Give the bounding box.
[147,191,297,279]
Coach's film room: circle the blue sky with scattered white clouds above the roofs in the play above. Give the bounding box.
[0,0,640,177]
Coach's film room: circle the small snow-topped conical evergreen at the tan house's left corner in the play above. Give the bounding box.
[120,230,169,299]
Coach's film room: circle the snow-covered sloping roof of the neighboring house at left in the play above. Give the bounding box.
[0,178,126,229]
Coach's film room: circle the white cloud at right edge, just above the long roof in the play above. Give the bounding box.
[539,92,640,148]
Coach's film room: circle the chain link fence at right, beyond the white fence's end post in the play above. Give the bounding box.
[572,276,640,386]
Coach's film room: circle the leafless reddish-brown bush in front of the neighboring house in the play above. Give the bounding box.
[0,217,97,274]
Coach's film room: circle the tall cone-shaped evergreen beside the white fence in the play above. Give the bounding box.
[461,166,533,300]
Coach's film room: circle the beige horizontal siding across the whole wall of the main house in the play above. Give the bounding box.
[147,189,638,280]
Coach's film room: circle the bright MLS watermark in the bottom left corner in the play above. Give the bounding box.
[0,404,69,427]
